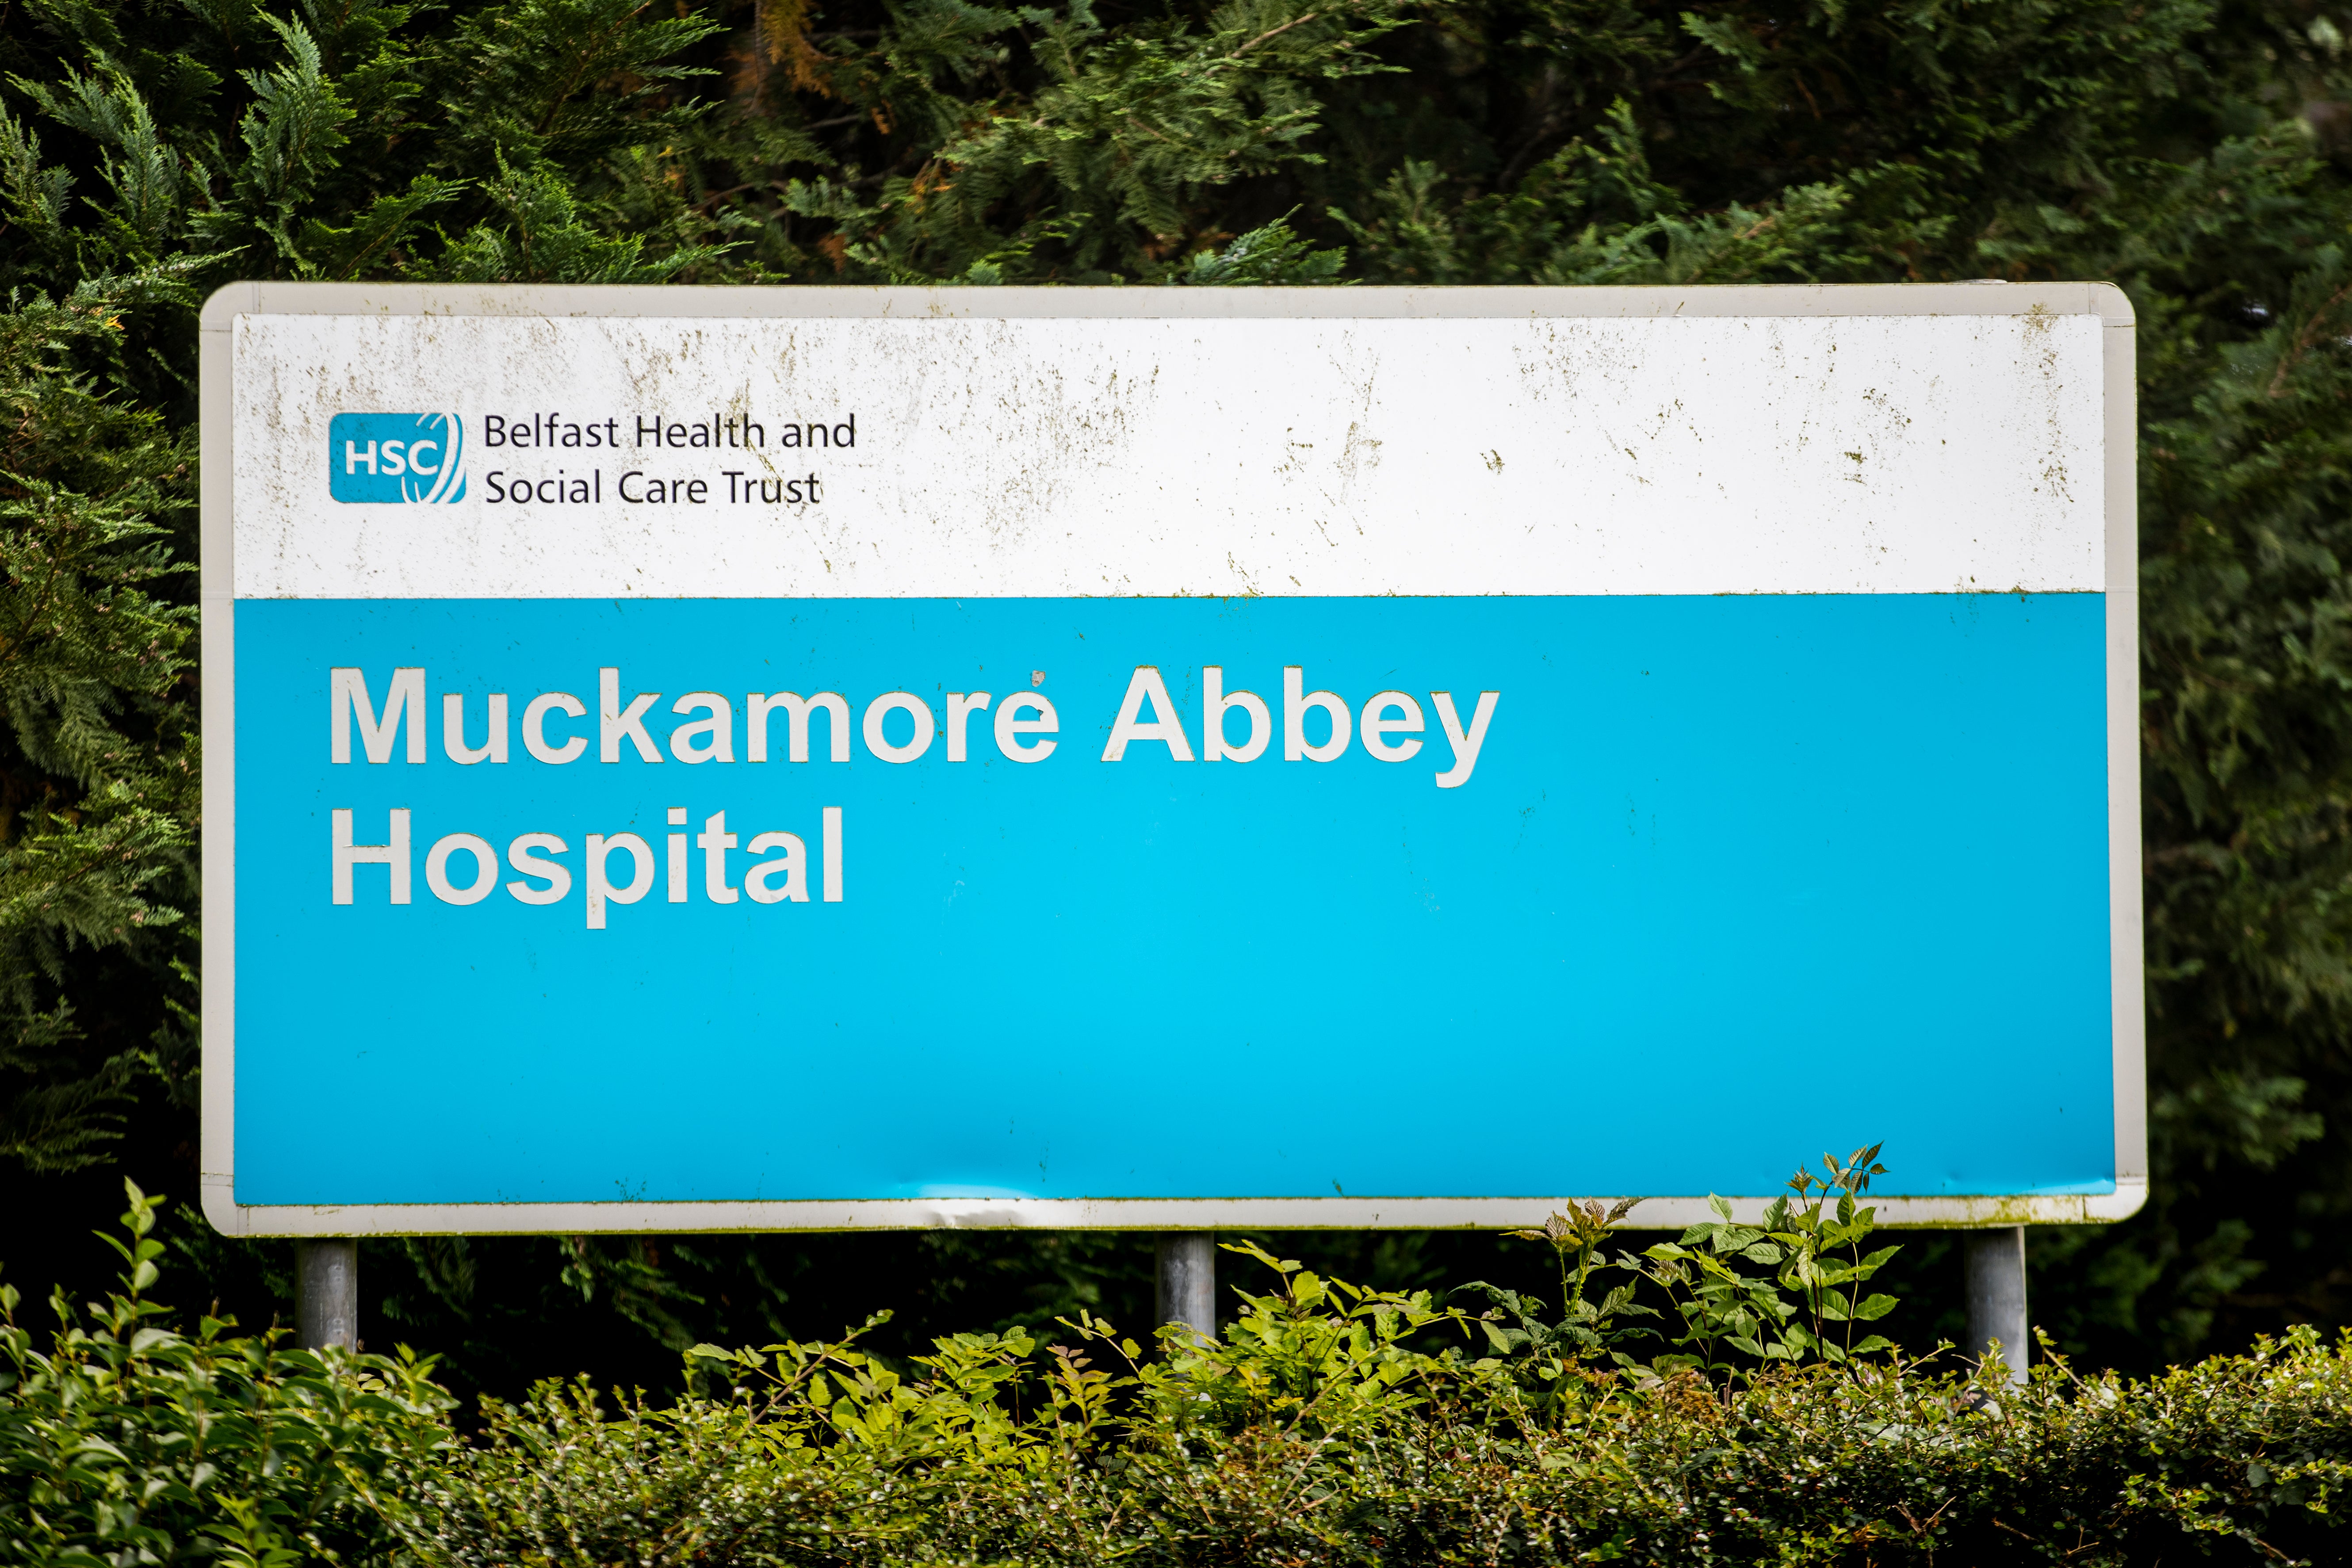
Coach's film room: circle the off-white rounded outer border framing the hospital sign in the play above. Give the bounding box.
[198,282,2147,1236]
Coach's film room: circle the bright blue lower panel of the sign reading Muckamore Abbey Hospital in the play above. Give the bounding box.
[237,595,2112,1204]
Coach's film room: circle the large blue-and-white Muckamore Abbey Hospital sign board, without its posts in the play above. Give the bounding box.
[202,284,2145,1234]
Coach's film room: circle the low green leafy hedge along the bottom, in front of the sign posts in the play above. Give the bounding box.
[0,1192,2352,1568]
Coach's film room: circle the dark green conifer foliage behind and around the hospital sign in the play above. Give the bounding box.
[0,0,2352,1387]
